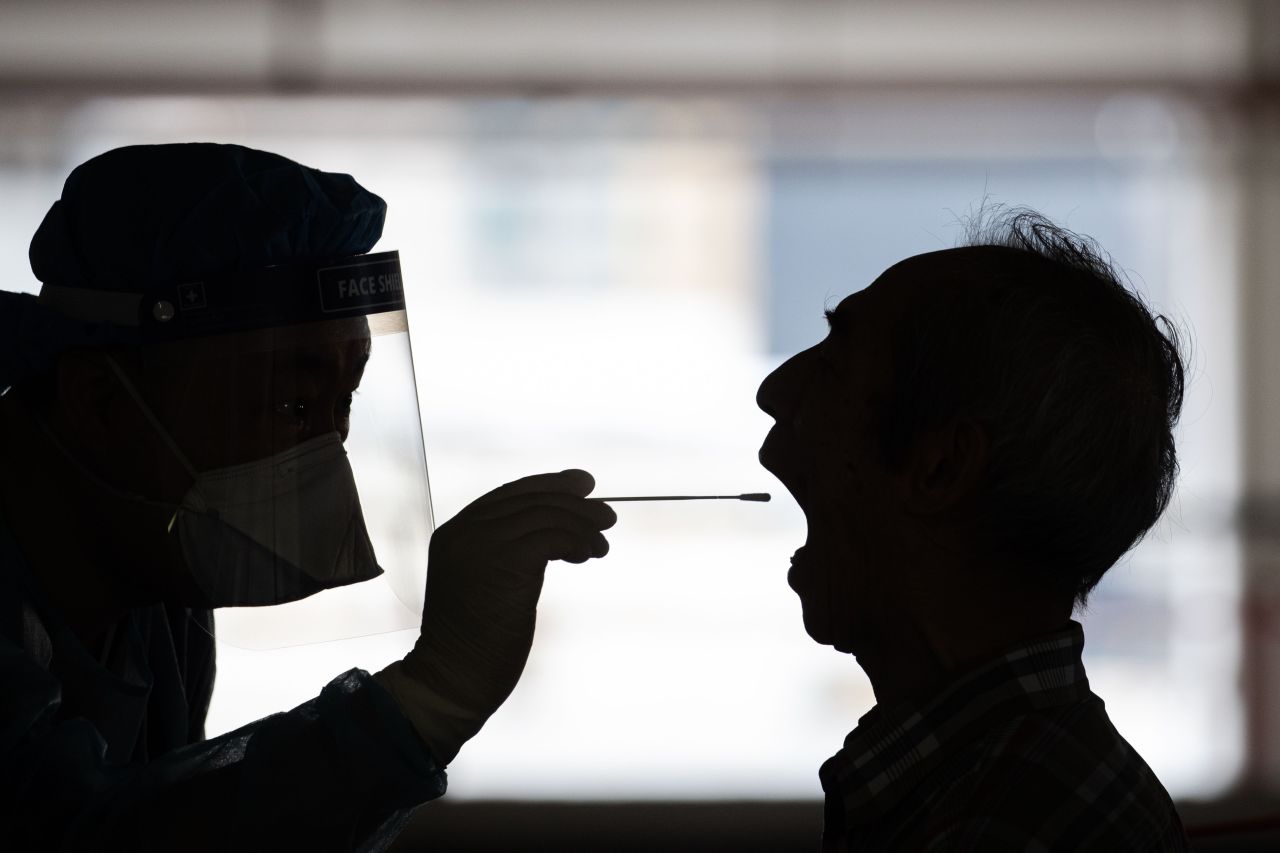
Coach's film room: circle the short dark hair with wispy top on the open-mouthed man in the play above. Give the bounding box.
[878,207,1185,605]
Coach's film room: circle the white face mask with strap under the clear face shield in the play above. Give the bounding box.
[108,356,383,607]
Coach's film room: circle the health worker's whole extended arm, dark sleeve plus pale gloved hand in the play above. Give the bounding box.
[0,470,616,853]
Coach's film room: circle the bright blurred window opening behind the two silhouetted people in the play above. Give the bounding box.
[0,96,1242,798]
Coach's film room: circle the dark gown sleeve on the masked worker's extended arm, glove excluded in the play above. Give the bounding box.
[0,639,445,852]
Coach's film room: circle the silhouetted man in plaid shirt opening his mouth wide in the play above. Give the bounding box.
[758,211,1187,852]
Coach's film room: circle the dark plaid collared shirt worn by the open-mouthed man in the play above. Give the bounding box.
[818,621,1188,853]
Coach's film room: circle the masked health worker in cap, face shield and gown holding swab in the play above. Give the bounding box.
[0,145,614,853]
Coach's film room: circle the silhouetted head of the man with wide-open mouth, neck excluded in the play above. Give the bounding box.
[758,210,1184,652]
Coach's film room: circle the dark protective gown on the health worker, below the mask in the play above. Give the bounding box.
[0,519,445,852]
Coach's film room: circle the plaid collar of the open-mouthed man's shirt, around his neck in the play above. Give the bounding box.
[818,620,1089,826]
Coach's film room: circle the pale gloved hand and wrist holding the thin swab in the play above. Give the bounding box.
[374,470,617,766]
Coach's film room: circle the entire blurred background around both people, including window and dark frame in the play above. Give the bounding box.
[0,0,1280,850]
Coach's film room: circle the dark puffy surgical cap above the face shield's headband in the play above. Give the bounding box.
[31,142,387,291]
